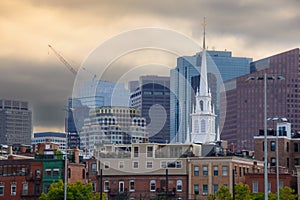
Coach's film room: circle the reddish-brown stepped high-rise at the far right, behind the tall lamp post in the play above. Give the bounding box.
[221,48,300,150]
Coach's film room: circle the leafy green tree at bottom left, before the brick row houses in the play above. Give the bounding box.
[40,180,106,200]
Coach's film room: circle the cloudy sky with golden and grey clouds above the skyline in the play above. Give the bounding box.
[0,0,300,132]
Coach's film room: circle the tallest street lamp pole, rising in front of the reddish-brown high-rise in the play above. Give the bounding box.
[246,73,284,200]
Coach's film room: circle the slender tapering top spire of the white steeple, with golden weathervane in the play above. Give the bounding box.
[199,17,208,96]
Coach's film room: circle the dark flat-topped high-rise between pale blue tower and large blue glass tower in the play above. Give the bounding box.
[129,76,170,143]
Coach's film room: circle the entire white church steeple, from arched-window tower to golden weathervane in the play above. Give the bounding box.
[187,18,216,144]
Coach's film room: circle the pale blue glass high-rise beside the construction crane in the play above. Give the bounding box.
[65,79,129,148]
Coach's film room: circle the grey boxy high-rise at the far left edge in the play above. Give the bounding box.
[0,99,32,145]
